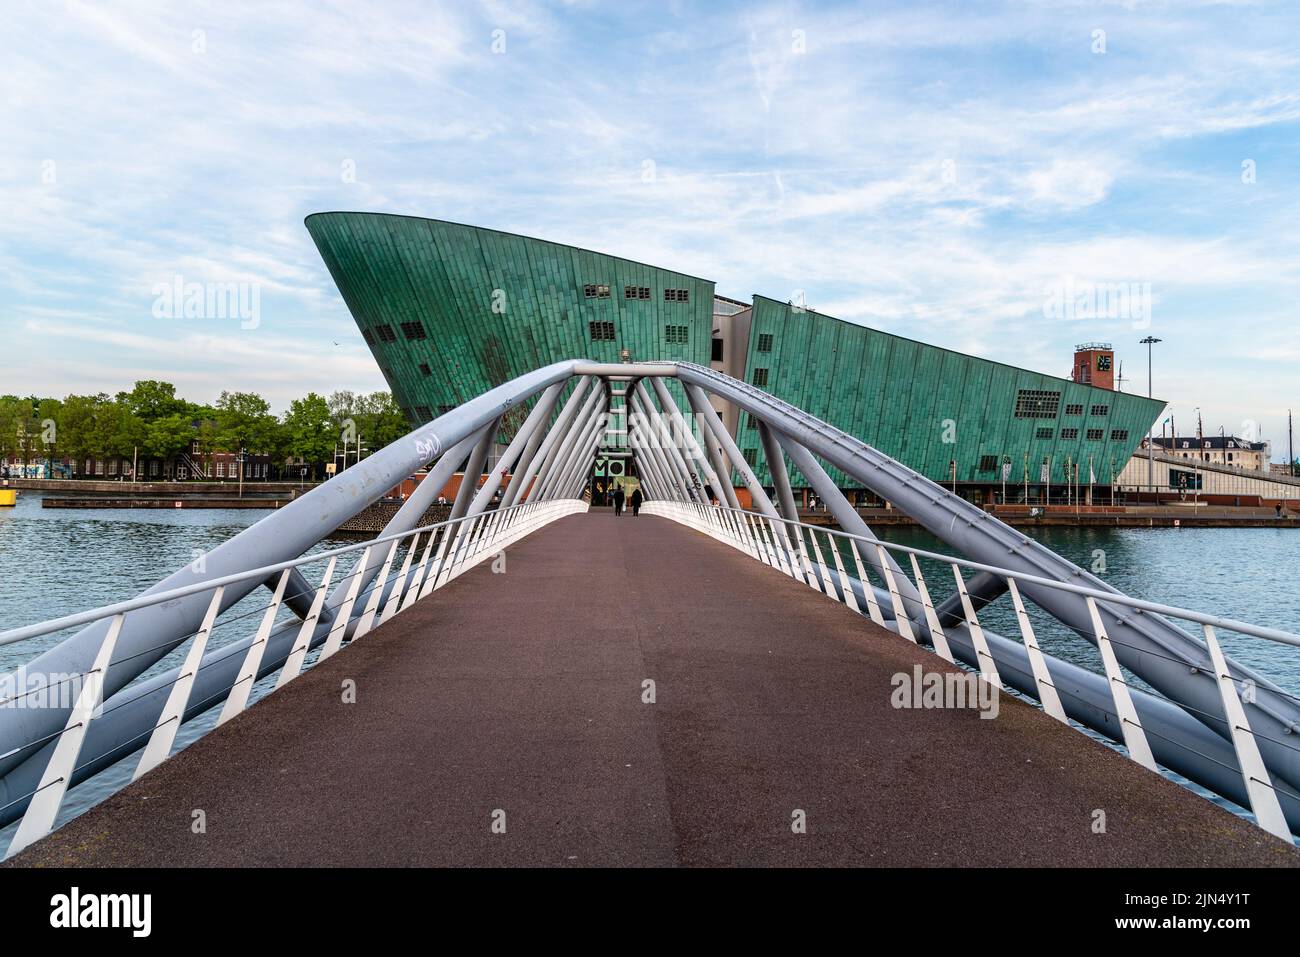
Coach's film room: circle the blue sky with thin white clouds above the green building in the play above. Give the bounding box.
[0,0,1300,458]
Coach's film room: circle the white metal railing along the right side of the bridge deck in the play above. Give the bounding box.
[642,501,1300,843]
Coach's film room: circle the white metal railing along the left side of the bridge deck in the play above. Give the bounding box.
[0,499,588,856]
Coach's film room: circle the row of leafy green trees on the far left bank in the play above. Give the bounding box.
[0,380,410,477]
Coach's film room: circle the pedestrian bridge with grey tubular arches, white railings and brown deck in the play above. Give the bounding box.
[0,363,1300,866]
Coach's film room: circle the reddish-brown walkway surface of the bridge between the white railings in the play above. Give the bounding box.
[8,511,1300,867]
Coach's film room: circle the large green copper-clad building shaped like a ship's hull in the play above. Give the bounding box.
[307,212,1164,499]
